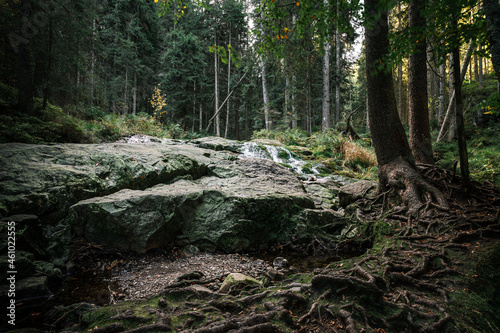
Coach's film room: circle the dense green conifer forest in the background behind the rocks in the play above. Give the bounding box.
[0,1,499,184]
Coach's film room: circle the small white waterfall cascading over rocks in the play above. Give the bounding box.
[241,142,319,175]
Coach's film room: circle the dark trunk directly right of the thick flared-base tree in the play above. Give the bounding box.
[408,0,434,164]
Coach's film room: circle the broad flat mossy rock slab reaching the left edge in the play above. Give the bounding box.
[0,143,232,217]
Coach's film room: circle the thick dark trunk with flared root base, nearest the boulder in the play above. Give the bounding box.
[365,0,448,214]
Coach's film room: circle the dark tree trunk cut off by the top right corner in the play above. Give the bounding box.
[483,0,500,104]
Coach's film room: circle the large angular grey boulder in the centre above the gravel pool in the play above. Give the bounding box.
[70,159,314,252]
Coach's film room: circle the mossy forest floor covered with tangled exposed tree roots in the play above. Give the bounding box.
[48,167,500,333]
